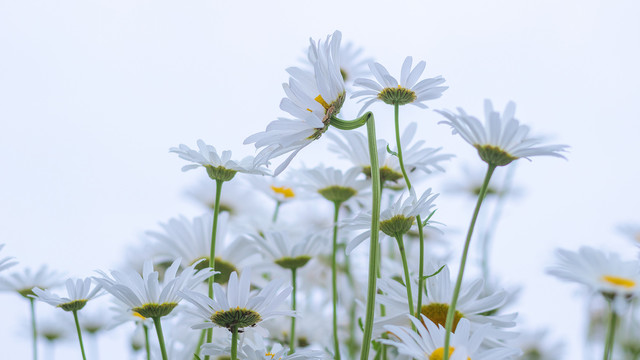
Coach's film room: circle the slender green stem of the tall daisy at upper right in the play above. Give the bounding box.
[443,164,496,360]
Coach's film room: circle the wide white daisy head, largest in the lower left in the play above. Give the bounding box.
[94,259,216,318]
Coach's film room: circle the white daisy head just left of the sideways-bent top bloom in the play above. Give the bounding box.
[169,140,271,181]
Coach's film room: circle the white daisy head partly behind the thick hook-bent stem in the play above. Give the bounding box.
[343,188,438,254]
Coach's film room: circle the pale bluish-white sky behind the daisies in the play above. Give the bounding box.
[0,0,640,359]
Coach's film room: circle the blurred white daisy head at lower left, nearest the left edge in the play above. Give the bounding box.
[0,265,62,297]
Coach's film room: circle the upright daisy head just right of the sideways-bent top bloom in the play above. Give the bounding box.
[351,56,449,114]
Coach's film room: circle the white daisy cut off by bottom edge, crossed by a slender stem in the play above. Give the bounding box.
[379,315,520,360]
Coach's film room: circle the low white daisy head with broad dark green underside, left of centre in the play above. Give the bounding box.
[181,268,293,331]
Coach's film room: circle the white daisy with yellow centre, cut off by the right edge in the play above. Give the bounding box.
[547,246,640,297]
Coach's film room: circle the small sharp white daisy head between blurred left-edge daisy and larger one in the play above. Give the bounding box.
[32,278,102,311]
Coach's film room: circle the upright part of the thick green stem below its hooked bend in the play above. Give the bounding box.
[360,113,380,360]
